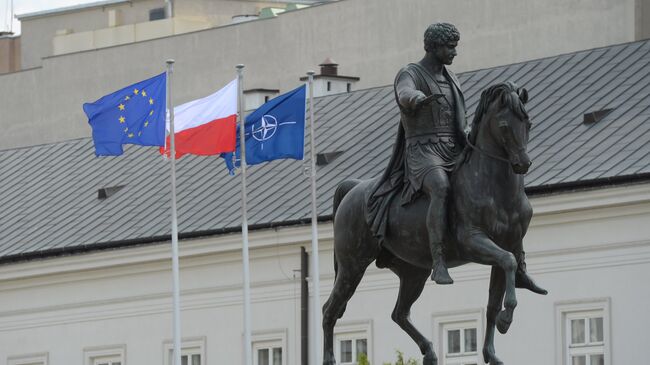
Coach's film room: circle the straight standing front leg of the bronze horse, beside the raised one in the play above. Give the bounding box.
[483,267,505,365]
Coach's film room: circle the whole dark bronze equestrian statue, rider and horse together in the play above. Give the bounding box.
[323,23,546,365]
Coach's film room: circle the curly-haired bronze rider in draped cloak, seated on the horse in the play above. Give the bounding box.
[366,23,544,292]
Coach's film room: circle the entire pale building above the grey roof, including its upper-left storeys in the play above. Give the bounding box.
[0,0,650,148]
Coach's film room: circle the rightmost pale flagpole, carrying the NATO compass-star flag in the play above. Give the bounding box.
[307,71,321,365]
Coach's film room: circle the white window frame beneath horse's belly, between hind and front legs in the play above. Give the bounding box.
[432,308,485,365]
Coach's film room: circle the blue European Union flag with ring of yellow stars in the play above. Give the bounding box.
[83,73,167,156]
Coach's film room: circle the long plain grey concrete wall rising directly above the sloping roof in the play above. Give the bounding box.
[0,0,636,149]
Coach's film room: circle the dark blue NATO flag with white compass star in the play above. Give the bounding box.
[221,85,307,174]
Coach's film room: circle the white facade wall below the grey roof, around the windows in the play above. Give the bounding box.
[0,184,650,365]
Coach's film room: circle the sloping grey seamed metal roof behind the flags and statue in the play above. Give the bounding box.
[0,41,650,262]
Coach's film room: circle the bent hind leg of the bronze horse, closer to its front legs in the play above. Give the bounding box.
[390,259,438,365]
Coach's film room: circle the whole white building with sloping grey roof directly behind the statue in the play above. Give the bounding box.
[0,34,650,365]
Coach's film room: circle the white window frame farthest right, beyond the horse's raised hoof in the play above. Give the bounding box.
[555,297,612,365]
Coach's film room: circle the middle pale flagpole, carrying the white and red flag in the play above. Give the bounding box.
[236,64,253,365]
